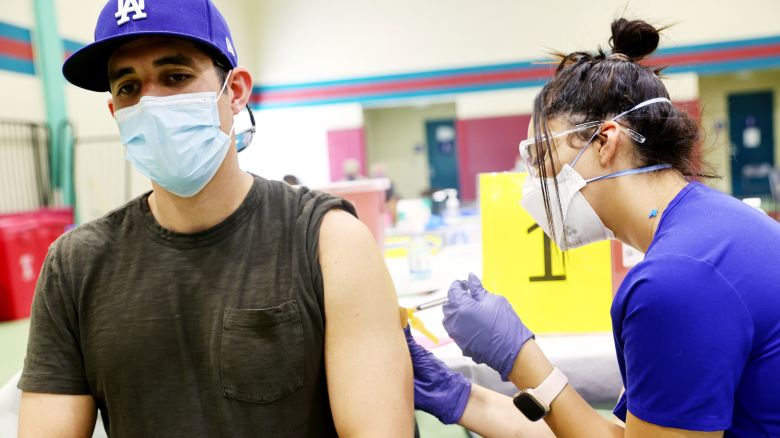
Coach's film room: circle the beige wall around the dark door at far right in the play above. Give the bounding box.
[699,70,780,193]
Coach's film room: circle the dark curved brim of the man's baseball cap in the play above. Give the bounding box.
[62,32,235,91]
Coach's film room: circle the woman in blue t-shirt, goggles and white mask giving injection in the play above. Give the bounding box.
[407,19,780,438]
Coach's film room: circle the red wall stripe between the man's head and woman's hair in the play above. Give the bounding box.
[256,67,551,103]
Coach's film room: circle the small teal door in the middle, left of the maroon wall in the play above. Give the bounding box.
[425,120,459,189]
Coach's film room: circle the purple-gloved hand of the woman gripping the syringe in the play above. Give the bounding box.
[444,274,534,381]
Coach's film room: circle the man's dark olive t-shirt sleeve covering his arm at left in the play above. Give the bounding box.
[18,249,90,395]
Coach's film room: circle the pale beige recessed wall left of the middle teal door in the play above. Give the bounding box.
[365,103,456,197]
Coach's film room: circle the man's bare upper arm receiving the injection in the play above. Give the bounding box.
[319,210,414,437]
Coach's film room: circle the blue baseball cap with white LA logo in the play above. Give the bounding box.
[62,0,238,91]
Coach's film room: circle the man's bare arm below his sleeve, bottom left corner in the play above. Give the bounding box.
[19,391,97,438]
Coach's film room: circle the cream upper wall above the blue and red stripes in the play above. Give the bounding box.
[253,0,780,84]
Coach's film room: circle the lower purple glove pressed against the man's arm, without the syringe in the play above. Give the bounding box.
[404,326,471,424]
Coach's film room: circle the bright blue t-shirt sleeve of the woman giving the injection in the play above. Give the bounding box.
[616,256,753,431]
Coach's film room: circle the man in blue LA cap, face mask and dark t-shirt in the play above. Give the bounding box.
[19,0,413,437]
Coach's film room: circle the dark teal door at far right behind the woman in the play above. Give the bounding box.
[728,91,775,198]
